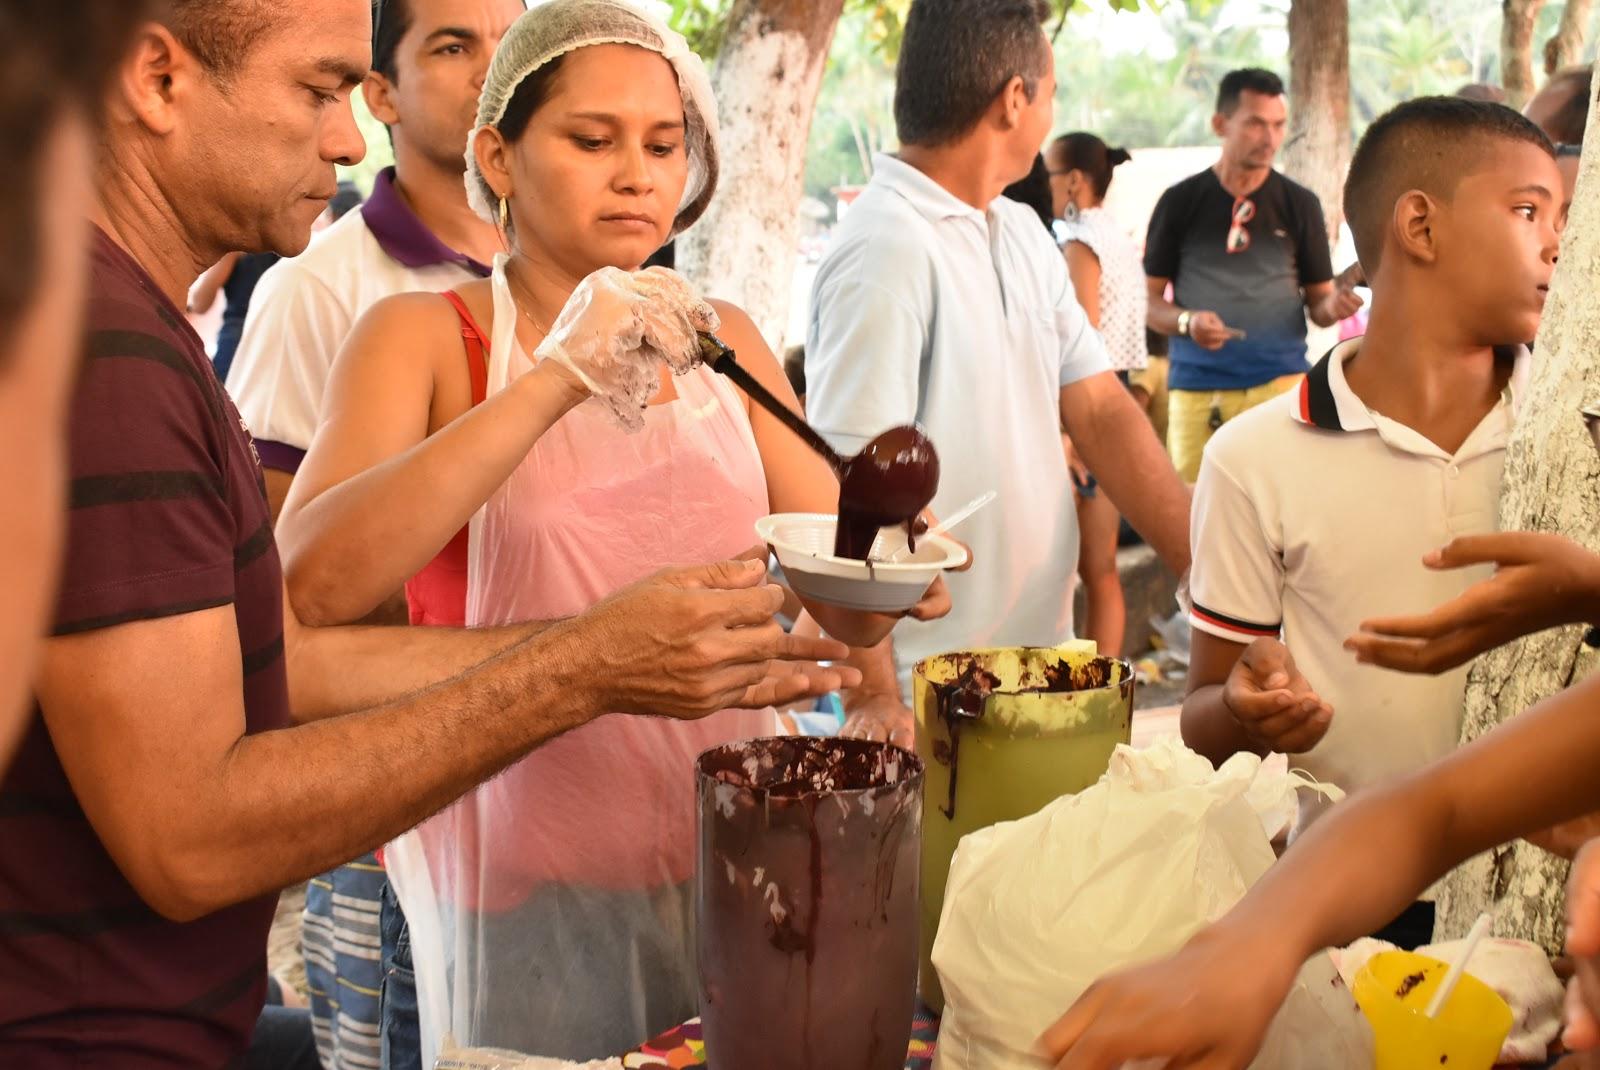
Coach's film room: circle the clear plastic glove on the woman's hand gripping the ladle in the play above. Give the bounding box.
[534,267,718,430]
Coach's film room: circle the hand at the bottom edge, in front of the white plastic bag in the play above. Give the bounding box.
[1038,923,1299,1070]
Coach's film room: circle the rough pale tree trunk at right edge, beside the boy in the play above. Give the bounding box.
[1435,81,1600,953]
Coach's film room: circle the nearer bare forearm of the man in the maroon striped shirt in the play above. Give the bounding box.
[173,625,597,916]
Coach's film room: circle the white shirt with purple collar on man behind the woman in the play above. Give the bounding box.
[227,171,488,472]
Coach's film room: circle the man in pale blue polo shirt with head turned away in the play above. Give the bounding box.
[806,0,1189,726]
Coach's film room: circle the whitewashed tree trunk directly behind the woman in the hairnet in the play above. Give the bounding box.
[678,0,845,349]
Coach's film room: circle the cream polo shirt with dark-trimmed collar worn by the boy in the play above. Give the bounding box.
[1190,339,1530,825]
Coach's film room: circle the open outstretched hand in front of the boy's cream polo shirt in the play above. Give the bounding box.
[1344,531,1600,673]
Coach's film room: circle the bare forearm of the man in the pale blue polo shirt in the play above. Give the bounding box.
[1067,385,1189,576]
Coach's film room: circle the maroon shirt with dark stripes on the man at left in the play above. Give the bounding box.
[0,232,288,1070]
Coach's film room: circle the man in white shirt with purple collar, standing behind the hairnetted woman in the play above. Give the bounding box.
[227,0,523,524]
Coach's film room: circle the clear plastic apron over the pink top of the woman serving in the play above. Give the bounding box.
[386,258,778,1065]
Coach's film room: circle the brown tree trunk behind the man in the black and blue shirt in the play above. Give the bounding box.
[1283,0,1350,241]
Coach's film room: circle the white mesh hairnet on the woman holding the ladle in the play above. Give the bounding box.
[467,0,717,237]
